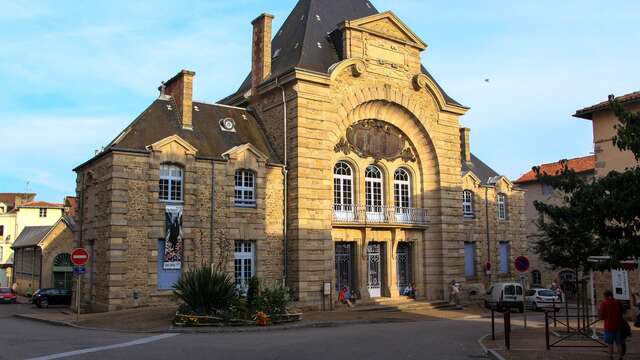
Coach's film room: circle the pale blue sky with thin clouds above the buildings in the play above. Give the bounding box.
[0,0,640,201]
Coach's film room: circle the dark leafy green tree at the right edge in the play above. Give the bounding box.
[534,96,640,271]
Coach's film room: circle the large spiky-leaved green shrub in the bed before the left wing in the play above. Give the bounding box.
[173,265,237,315]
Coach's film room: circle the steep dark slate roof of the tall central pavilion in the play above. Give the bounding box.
[220,0,462,106]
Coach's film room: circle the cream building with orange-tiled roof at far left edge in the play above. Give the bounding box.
[0,193,63,286]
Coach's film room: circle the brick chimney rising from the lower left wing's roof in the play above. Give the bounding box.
[160,70,196,130]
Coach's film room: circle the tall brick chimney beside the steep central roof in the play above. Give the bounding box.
[251,13,274,95]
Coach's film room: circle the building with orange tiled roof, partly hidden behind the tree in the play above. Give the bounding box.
[515,155,596,287]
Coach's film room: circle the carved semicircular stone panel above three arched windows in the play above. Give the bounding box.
[334,120,416,162]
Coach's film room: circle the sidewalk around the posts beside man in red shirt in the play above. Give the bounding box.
[483,323,640,360]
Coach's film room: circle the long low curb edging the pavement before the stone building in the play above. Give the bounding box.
[13,314,412,334]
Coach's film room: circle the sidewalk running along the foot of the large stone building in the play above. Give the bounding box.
[16,304,482,332]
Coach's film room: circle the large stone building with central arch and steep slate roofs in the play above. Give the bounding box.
[75,0,526,311]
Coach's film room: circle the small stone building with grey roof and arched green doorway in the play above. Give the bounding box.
[12,215,75,294]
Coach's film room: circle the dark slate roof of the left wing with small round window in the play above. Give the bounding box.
[79,99,279,167]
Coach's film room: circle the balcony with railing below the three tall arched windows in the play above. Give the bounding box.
[333,205,428,226]
